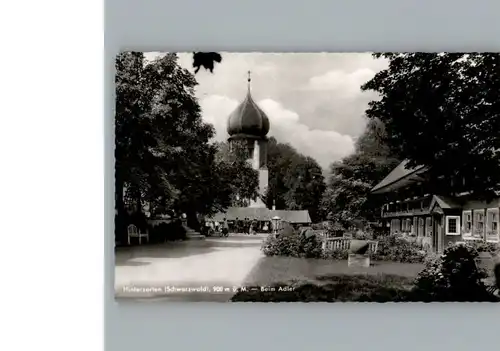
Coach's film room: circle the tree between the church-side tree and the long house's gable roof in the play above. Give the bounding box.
[322,119,400,227]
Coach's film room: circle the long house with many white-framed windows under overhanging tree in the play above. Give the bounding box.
[371,161,500,252]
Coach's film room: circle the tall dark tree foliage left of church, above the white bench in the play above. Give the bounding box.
[115,52,242,228]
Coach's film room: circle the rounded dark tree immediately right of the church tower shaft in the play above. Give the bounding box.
[266,137,326,221]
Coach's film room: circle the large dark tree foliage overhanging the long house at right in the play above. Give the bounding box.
[362,53,500,196]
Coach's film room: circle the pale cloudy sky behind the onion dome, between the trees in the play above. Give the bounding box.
[146,52,387,169]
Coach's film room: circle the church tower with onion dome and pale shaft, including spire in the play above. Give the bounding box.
[227,71,270,207]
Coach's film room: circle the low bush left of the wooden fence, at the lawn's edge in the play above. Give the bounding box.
[262,231,323,258]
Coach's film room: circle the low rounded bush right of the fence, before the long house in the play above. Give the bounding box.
[372,235,426,263]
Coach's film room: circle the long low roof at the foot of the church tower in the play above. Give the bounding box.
[210,207,312,223]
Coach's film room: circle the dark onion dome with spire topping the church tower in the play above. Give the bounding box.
[227,72,269,139]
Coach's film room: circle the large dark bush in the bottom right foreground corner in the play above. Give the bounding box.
[414,244,496,301]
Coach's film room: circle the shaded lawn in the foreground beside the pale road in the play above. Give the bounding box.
[232,256,423,302]
